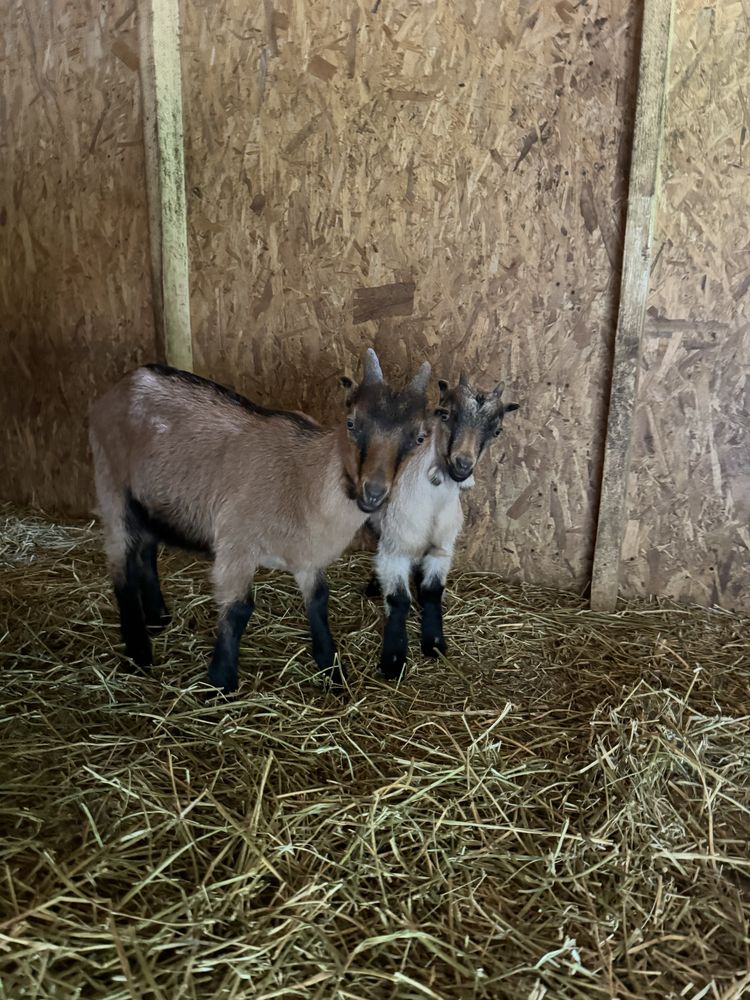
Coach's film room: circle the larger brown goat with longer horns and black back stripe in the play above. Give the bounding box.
[90,350,430,693]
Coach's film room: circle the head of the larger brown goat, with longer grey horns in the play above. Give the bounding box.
[341,352,430,514]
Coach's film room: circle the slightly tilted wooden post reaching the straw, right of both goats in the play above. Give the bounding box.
[591,0,673,611]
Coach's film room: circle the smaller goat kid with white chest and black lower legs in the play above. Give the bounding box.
[367,375,518,678]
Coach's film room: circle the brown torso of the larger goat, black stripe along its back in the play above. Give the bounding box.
[91,368,346,561]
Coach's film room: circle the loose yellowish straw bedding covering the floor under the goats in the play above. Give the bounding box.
[0,508,750,1000]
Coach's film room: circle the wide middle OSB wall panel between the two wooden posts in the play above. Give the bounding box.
[182,0,640,588]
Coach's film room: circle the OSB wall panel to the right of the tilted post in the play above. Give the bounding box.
[622,0,750,611]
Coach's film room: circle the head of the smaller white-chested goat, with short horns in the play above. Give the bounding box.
[435,375,518,483]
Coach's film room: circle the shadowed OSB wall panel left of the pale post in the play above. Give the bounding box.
[0,0,154,513]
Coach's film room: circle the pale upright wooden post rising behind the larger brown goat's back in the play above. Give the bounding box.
[138,0,193,371]
